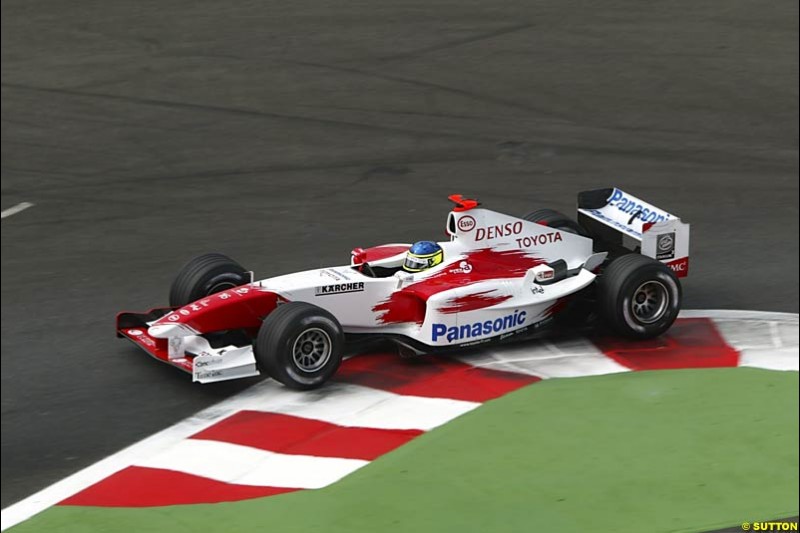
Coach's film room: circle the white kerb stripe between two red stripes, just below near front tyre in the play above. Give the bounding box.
[247,384,480,430]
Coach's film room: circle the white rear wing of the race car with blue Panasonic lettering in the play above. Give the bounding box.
[578,188,689,278]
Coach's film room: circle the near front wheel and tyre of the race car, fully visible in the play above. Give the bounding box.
[255,302,344,390]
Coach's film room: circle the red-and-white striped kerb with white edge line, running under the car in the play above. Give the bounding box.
[2,311,798,529]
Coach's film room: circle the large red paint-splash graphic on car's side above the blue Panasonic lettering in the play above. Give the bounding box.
[372,248,544,324]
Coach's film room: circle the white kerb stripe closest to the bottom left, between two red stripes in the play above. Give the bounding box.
[136,439,369,489]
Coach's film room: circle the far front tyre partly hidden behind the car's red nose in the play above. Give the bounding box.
[169,254,250,307]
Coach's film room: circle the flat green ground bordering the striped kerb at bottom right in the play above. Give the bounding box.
[12,368,798,533]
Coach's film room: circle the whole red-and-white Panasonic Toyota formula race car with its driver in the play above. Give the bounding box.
[117,189,689,389]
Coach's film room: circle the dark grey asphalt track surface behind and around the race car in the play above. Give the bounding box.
[2,0,798,507]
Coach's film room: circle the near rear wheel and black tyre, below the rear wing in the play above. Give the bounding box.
[597,254,681,339]
